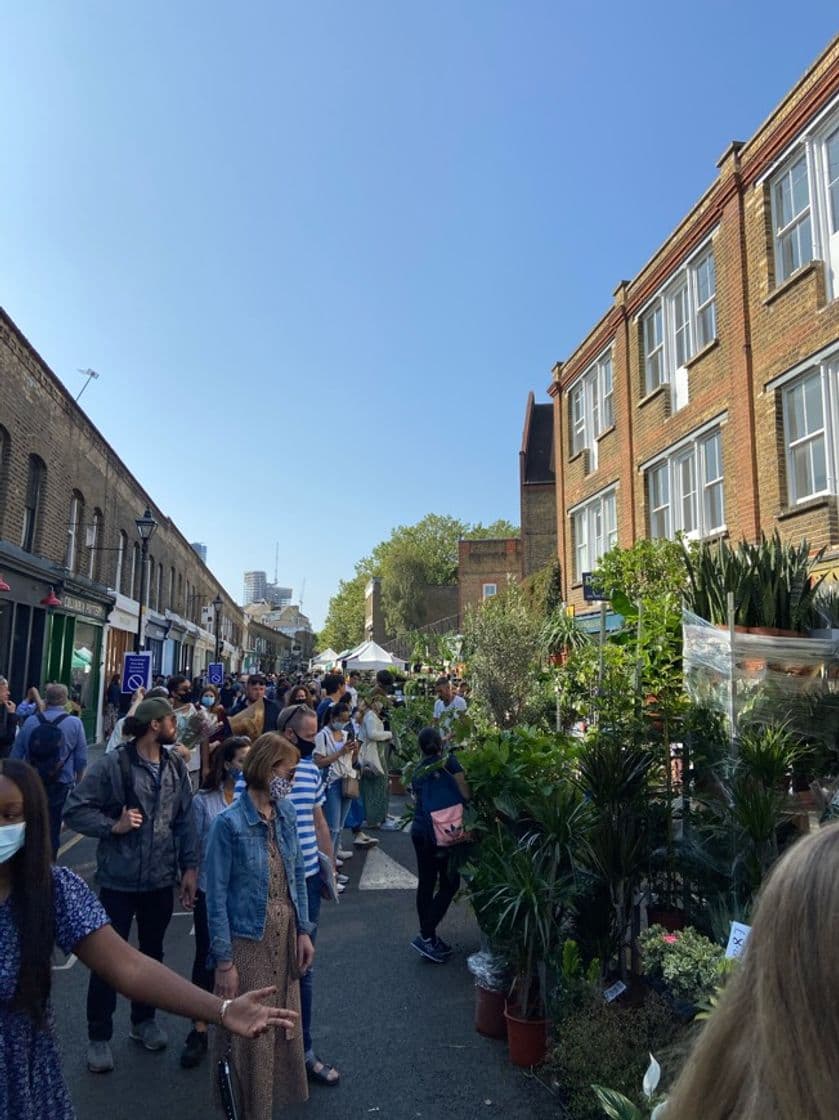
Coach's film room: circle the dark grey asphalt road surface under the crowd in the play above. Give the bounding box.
[53,788,558,1120]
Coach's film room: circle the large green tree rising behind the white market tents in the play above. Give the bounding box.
[318,513,519,651]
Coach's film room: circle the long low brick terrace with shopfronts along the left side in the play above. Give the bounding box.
[0,309,245,738]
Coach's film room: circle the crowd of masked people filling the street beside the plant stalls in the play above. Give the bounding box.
[0,672,468,1120]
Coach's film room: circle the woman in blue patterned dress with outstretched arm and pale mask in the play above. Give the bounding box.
[0,758,299,1120]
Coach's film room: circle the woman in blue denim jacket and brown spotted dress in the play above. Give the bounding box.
[206,731,315,1120]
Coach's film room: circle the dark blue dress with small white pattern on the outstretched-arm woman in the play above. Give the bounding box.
[0,867,110,1120]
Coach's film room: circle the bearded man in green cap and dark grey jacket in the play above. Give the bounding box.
[64,698,198,1073]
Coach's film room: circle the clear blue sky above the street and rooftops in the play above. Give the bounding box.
[0,0,839,625]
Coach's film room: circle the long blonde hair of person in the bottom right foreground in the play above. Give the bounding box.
[664,824,839,1120]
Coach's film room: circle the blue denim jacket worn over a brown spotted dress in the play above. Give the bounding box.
[206,792,315,963]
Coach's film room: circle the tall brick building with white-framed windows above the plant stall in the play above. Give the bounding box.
[549,37,839,606]
